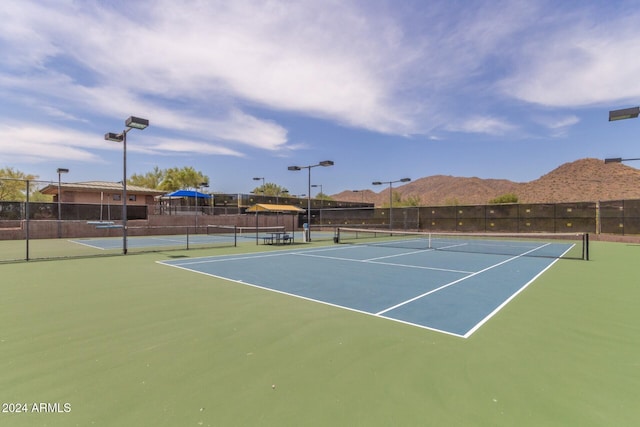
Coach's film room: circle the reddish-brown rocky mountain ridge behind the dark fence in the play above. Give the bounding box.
[332,159,640,206]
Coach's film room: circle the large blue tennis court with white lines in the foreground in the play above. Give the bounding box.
[161,244,571,338]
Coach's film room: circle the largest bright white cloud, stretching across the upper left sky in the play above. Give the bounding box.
[3,1,424,135]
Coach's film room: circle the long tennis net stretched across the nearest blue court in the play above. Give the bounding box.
[335,227,589,260]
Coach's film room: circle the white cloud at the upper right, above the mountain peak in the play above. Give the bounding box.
[501,8,640,107]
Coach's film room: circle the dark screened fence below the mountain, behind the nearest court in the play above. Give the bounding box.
[311,200,640,235]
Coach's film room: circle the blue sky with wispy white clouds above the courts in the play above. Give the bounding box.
[0,0,640,194]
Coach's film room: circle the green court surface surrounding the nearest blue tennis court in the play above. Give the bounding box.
[0,242,640,426]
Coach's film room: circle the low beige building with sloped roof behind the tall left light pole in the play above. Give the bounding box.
[40,181,166,206]
